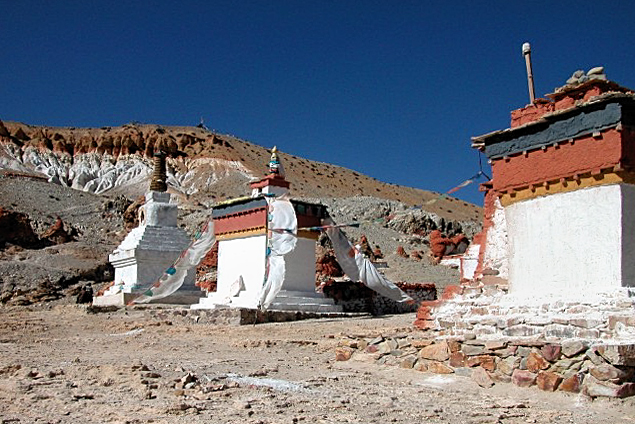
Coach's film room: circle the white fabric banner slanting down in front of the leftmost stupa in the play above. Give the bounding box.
[133,219,216,303]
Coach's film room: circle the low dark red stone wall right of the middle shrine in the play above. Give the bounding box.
[322,280,437,315]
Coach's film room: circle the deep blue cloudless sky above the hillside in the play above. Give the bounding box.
[0,0,635,204]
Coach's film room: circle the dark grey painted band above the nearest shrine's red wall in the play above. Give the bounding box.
[485,103,622,159]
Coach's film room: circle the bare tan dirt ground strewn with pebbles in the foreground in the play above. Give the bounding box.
[0,304,635,423]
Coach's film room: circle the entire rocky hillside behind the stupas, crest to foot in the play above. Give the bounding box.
[0,122,481,305]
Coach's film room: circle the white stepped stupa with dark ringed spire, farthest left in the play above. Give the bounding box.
[93,152,204,306]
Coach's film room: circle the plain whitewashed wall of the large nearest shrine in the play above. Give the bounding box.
[505,184,635,298]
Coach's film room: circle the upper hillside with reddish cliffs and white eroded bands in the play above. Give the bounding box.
[0,122,480,221]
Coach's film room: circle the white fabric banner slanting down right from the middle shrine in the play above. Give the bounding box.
[326,227,412,302]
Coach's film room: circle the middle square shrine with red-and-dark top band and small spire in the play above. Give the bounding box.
[192,147,342,312]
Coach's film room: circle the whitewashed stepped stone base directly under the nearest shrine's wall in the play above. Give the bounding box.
[415,285,635,343]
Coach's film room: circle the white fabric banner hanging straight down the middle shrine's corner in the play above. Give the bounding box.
[260,197,298,309]
